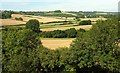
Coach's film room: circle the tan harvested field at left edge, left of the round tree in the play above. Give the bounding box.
[0,19,26,26]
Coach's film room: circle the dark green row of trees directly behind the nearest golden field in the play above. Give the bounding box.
[40,28,85,38]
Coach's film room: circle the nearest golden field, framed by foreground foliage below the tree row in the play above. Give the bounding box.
[41,38,74,50]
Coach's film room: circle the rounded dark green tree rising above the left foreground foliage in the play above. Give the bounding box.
[26,19,40,32]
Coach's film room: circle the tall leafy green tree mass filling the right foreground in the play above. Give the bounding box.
[71,19,120,72]
